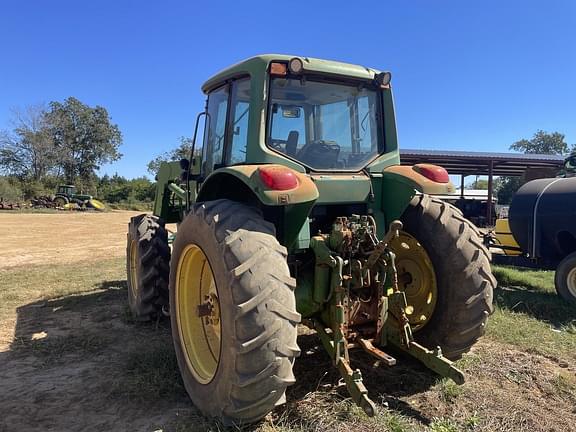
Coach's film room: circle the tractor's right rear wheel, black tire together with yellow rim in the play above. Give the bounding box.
[394,195,496,360]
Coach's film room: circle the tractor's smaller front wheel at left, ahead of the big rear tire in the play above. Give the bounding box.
[126,214,170,321]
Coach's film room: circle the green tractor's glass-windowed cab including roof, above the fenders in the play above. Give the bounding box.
[201,55,398,177]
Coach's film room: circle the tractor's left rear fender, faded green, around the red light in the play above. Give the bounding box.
[197,164,319,206]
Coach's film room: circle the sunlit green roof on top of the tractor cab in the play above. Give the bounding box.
[202,54,380,93]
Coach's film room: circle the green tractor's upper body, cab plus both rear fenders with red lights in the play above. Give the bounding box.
[184,54,453,243]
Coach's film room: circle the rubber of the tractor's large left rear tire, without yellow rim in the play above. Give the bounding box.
[170,200,300,424]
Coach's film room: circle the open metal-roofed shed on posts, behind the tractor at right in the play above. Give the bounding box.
[400,149,564,221]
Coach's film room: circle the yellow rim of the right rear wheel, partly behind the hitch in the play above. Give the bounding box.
[390,231,438,330]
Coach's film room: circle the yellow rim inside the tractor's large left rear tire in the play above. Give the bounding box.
[175,245,222,384]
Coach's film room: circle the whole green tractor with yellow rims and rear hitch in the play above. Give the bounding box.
[127,55,496,424]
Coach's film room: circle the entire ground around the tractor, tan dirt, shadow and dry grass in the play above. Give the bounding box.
[0,212,576,432]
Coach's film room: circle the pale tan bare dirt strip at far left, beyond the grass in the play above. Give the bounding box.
[0,211,138,269]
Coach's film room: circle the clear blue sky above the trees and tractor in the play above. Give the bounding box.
[0,0,576,177]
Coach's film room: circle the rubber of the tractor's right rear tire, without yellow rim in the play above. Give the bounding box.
[401,195,496,359]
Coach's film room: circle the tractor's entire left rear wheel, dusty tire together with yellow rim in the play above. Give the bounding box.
[169,200,300,424]
